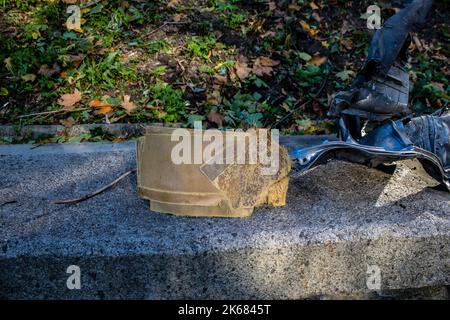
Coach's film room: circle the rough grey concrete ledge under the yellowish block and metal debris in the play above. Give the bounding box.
[0,139,450,299]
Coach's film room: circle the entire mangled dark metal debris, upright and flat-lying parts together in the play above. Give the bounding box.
[290,0,450,191]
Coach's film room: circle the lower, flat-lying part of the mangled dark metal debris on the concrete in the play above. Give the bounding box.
[290,110,450,191]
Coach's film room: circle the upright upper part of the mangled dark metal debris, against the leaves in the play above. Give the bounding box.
[329,0,433,122]
